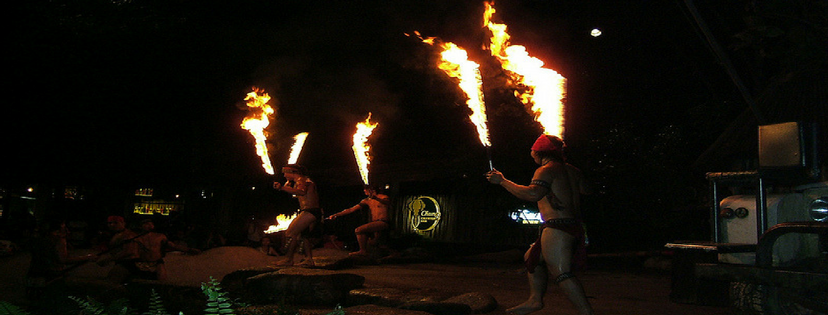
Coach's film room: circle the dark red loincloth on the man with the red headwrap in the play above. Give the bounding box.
[524,218,586,273]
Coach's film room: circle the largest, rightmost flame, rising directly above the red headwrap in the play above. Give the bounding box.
[483,2,566,138]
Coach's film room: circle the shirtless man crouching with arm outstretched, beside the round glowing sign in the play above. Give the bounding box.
[328,186,391,256]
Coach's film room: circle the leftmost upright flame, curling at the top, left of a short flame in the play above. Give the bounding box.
[241,89,274,175]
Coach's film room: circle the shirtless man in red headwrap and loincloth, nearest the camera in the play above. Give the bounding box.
[486,135,593,314]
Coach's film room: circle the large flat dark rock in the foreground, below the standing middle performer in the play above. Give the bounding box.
[237,268,365,306]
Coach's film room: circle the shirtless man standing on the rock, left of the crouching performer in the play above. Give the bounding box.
[273,164,323,266]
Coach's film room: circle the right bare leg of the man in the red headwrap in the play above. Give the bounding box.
[541,228,593,314]
